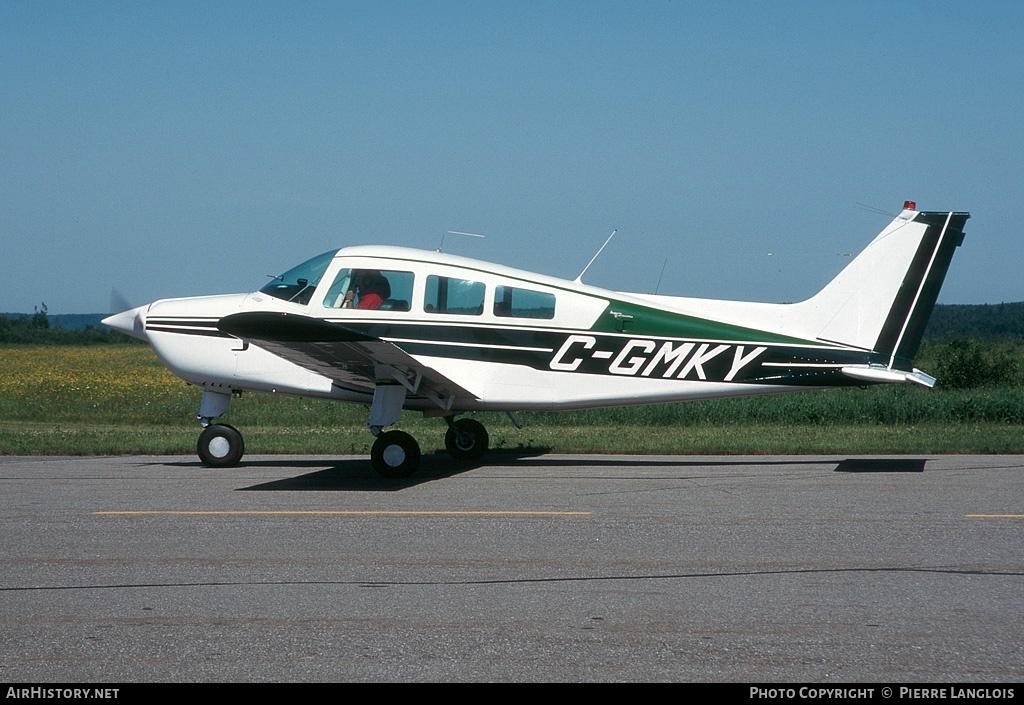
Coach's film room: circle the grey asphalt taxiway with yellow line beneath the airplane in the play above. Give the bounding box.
[0,455,1024,683]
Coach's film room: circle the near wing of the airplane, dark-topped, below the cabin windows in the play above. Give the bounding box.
[217,312,476,409]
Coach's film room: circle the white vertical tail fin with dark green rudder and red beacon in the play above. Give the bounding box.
[796,201,971,371]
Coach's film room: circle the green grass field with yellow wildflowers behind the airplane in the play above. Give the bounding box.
[0,345,1024,455]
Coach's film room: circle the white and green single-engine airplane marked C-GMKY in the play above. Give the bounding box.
[103,201,970,478]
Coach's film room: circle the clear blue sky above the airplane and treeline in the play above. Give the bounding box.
[0,0,1024,314]
